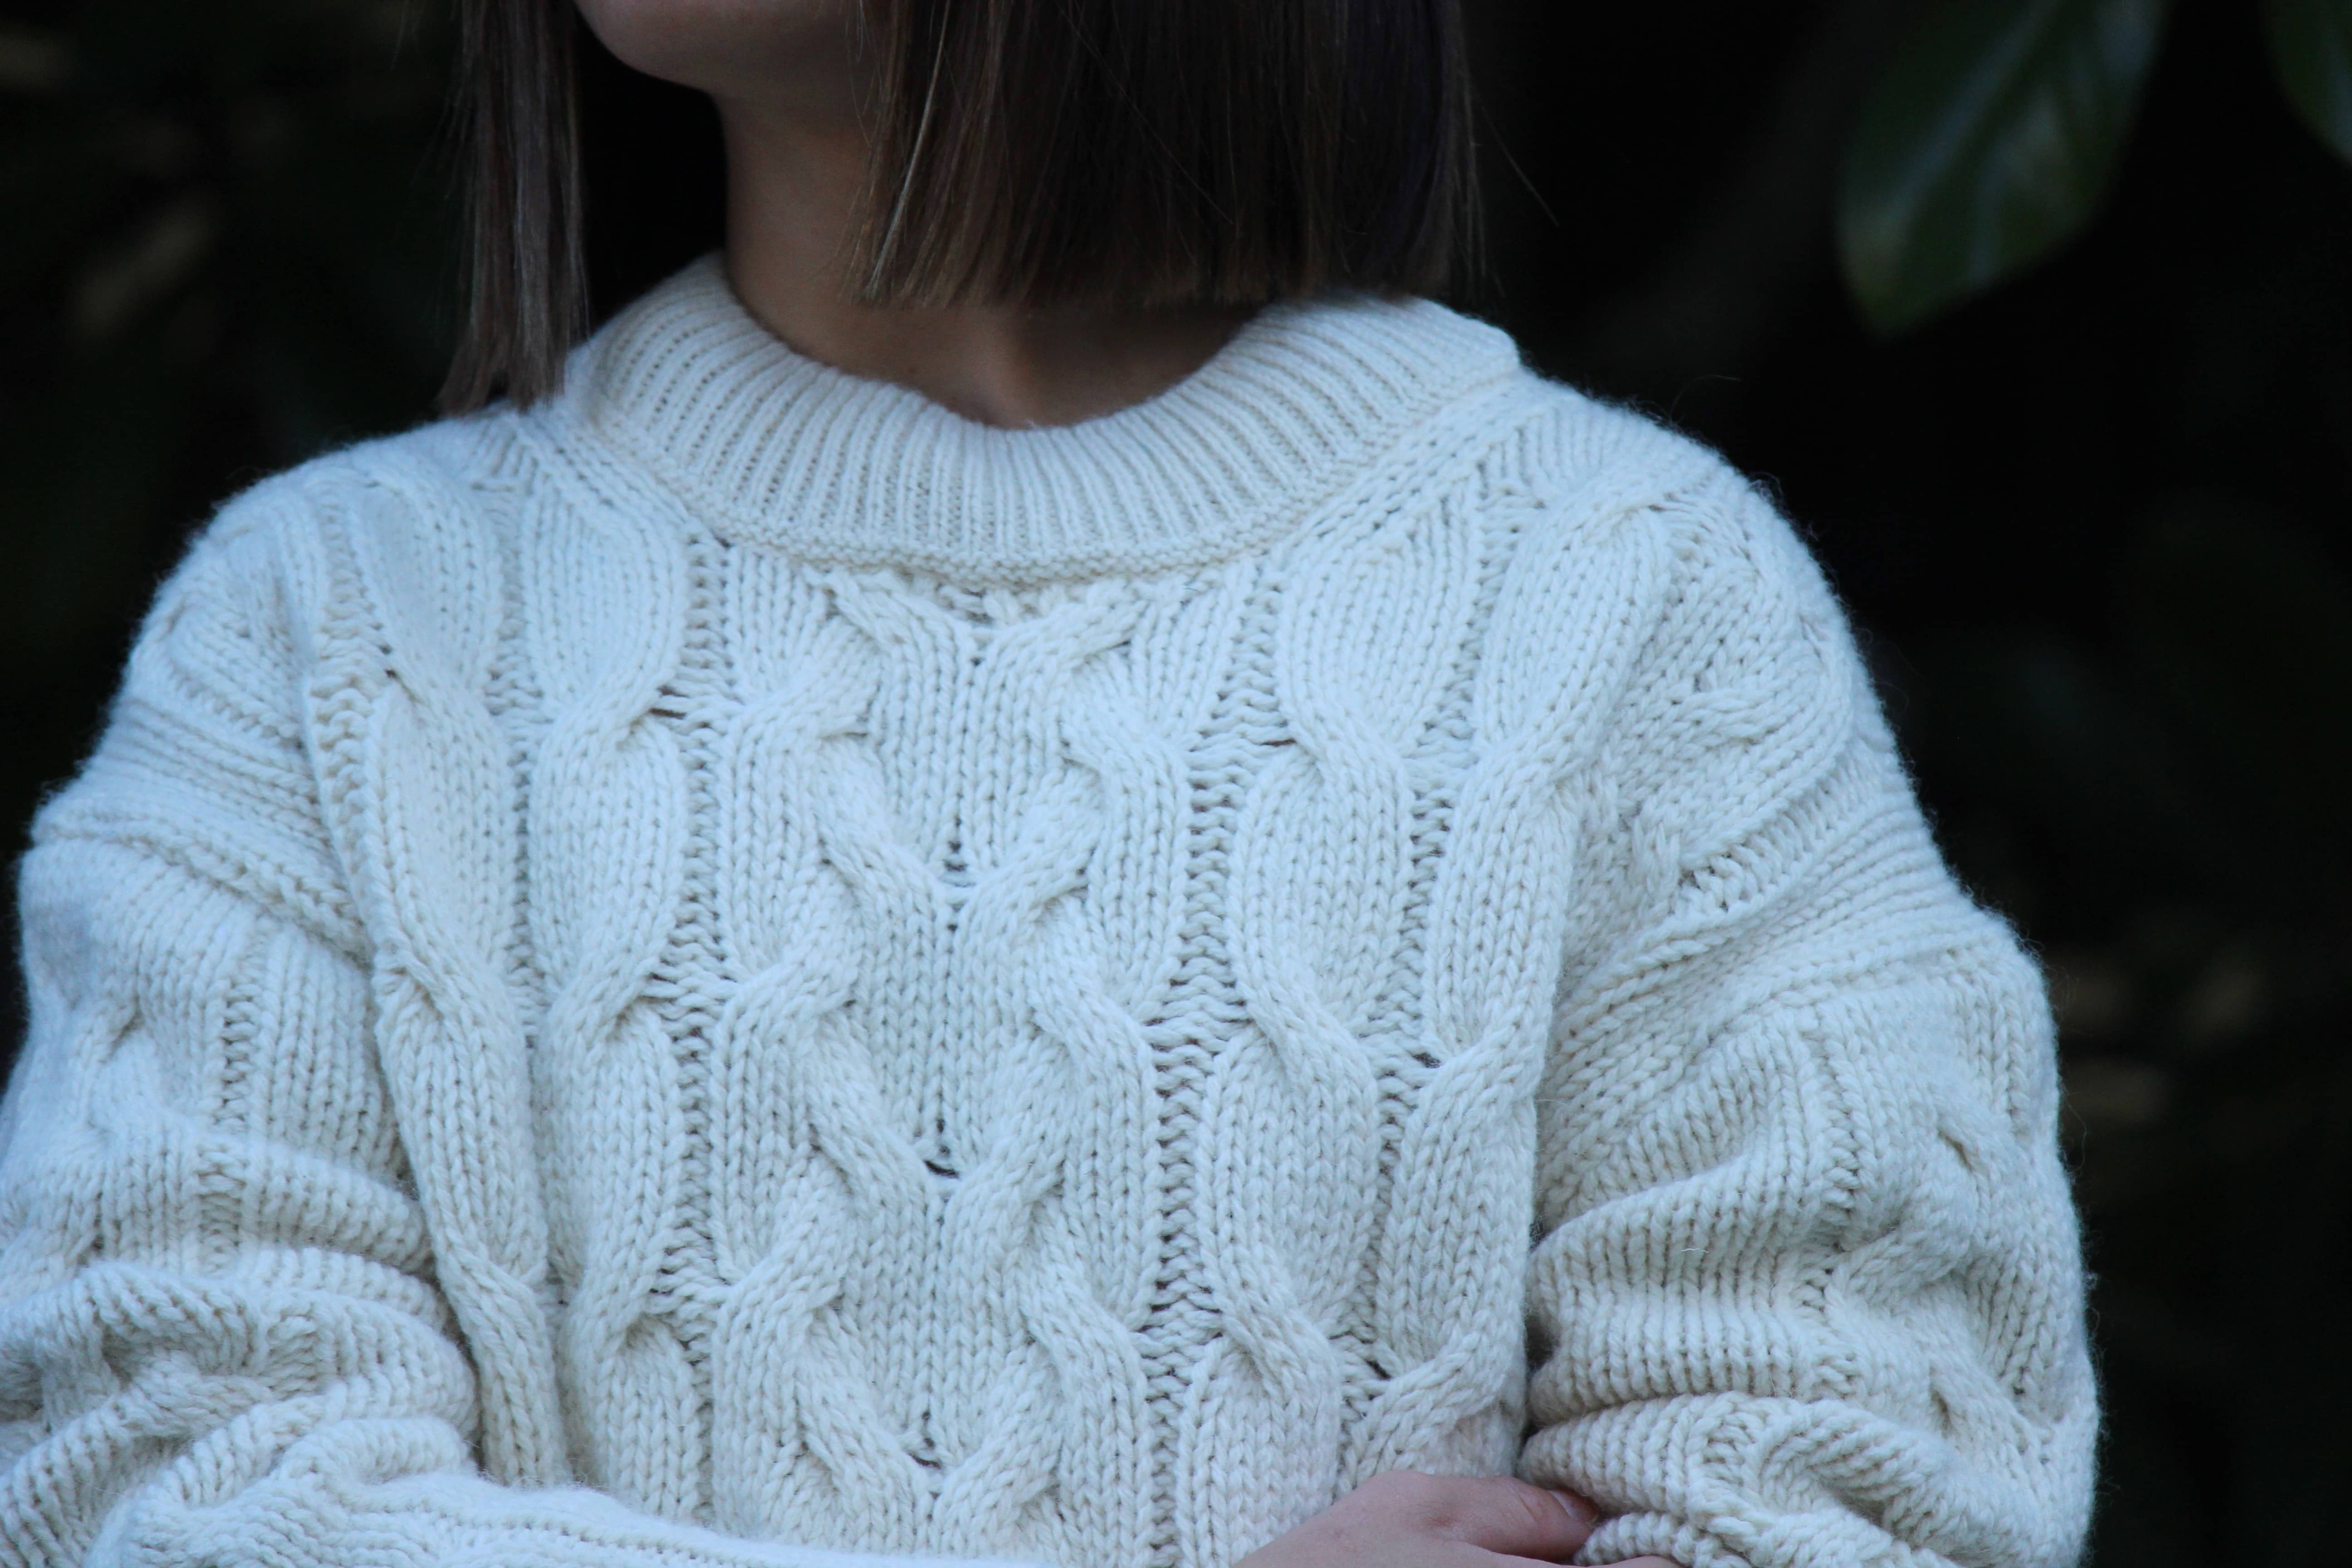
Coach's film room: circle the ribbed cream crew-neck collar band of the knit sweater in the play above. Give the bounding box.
[560,254,1519,583]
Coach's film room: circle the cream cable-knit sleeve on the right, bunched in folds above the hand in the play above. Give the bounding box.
[1522,472,2096,1568]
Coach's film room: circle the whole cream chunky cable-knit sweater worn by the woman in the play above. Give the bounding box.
[0,261,2096,1568]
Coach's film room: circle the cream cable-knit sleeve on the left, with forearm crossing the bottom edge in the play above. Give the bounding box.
[0,494,1030,1568]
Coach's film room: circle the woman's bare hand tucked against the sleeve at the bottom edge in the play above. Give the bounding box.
[1237,1469,1675,1568]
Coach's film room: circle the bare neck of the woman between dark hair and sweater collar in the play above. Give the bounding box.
[720,96,1249,428]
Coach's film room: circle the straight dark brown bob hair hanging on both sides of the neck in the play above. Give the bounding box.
[442,0,1477,412]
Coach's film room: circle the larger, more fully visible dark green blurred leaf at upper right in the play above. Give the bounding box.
[1837,0,2171,334]
